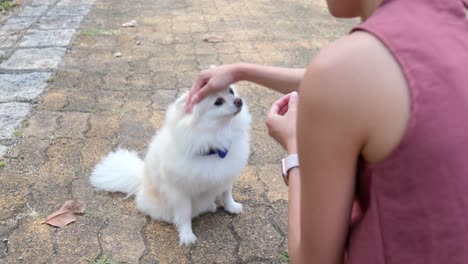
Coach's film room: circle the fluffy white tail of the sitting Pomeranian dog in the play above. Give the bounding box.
[90,149,144,196]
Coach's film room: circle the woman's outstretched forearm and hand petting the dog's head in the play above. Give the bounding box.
[186,63,305,111]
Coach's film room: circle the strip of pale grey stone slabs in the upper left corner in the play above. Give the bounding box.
[0,0,94,156]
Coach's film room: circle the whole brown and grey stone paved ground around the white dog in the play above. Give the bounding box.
[0,0,356,263]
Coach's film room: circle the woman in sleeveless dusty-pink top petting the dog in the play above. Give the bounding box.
[187,0,468,263]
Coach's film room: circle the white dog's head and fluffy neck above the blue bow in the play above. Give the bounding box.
[165,86,251,155]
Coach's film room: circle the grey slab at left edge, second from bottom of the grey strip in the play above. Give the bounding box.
[0,103,31,140]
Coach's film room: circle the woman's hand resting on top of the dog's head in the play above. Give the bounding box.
[185,64,238,112]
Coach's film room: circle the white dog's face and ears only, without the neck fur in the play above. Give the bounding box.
[168,85,245,128]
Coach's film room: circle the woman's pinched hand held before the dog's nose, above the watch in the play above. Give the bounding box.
[266,92,298,154]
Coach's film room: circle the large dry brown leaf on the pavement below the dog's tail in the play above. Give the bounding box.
[42,199,86,227]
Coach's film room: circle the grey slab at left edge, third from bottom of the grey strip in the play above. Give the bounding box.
[0,72,52,103]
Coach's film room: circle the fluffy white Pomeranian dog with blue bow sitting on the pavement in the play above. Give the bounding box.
[90,86,251,245]
